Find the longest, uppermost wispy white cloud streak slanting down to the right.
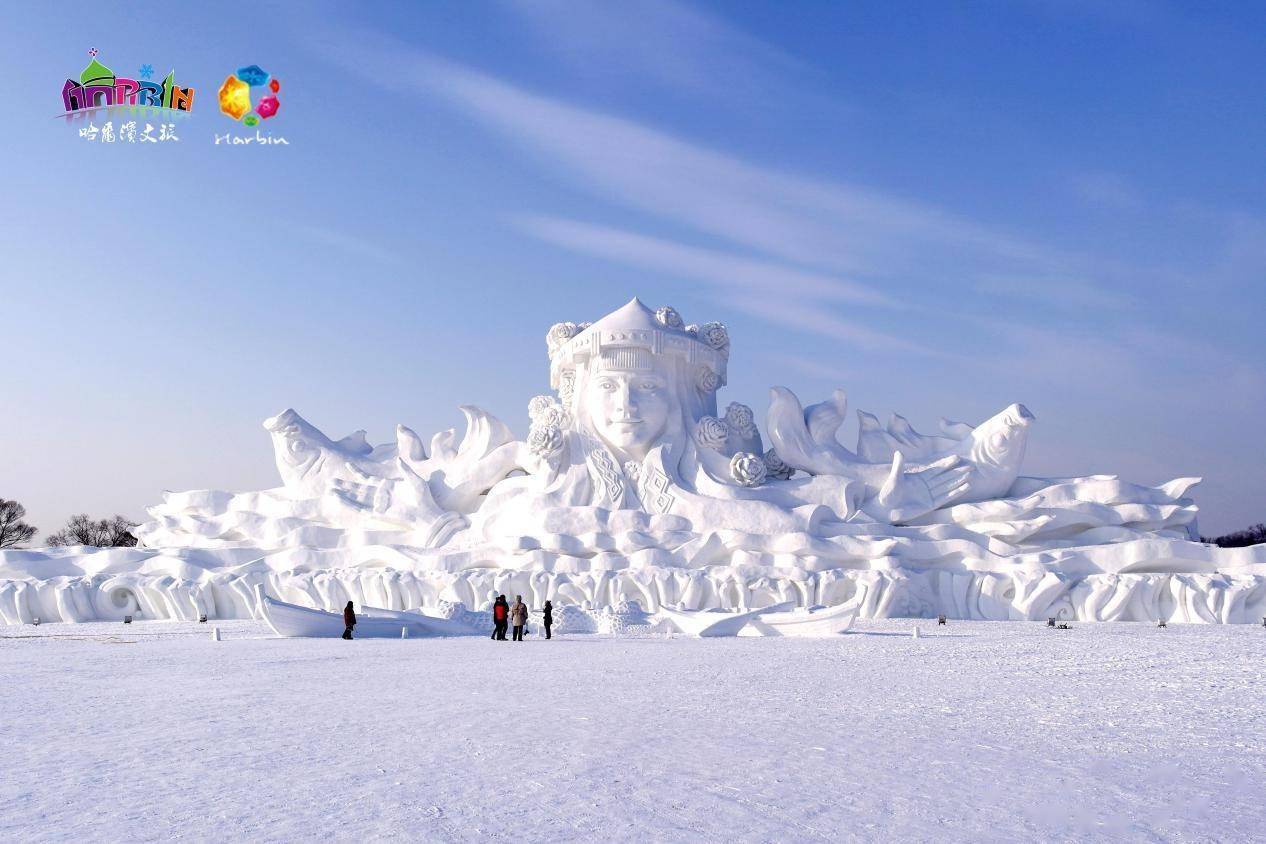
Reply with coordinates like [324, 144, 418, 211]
[313, 33, 1067, 286]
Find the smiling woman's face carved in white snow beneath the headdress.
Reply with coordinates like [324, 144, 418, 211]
[582, 364, 672, 461]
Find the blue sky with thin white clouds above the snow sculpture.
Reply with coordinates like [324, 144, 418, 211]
[0, 0, 1266, 533]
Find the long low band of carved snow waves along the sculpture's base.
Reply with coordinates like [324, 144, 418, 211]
[0, 548, 1266, 624]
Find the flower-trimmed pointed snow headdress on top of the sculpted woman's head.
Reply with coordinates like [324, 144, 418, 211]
[546, 297, 729, 392]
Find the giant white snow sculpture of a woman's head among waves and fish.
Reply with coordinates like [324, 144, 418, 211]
[0, 299, 1266, 634]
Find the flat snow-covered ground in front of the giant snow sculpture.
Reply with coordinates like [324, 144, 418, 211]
[0, 620, 1266, 841]
